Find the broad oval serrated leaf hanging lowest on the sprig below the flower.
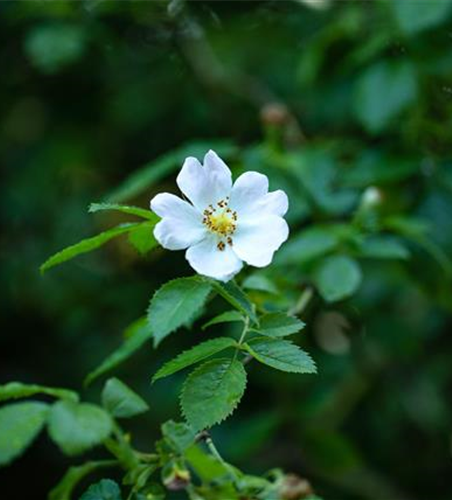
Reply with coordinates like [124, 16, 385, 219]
[181, 358, 246, 431]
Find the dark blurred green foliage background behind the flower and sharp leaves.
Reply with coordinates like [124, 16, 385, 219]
[0, 0, 452, 500]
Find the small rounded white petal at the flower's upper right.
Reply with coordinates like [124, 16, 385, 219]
[229, 172, 268, 215]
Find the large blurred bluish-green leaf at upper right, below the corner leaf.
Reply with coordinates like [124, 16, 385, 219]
[353, 61, 417, 133]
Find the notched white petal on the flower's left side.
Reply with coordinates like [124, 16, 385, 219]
[151, 193, 206, 250]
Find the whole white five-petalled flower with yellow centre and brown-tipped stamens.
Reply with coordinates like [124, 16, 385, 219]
[151, 151, 289, 281]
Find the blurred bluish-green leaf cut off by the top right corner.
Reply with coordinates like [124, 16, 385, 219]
[388, 0, 452, 36]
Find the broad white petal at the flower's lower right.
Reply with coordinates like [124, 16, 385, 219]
[233, 215, 289, 267]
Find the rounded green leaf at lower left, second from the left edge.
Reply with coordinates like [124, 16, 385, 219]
[49, 401, 112, 455]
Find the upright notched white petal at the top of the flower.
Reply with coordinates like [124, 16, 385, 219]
[177, 151, 232, 212]
